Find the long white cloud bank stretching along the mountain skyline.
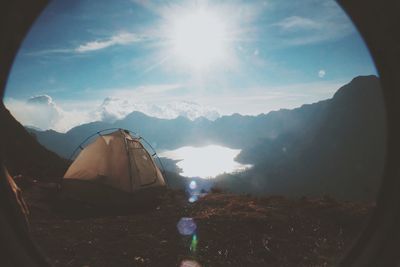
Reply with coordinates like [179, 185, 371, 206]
[5, 81, 345, 132]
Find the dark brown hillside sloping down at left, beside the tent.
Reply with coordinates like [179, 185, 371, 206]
[0, 104, 68, 179]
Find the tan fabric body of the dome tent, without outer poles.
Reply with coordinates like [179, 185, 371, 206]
[64, 130, 165, 193]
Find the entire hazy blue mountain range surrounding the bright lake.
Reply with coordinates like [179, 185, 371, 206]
[27, 76, 386, 199]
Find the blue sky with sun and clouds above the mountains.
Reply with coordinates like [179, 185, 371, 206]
[4, 0, 377, 132]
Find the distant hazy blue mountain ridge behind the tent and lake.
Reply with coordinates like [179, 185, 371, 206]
[28, 101, 326, 158]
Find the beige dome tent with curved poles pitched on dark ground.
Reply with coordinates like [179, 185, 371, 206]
[61, 129, 166, 207]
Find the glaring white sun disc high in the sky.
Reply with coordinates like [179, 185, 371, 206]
[169, 9, 228, 70]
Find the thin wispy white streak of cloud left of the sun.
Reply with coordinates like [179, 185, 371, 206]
[75, 33, 143, 53]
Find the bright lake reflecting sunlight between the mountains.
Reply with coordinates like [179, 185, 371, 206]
[159, 145, 251, 178]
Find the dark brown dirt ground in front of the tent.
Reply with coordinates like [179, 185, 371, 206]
[24, 186, 373, 267]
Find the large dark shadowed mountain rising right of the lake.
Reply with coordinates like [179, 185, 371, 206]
[218, 76, 386, 199]
